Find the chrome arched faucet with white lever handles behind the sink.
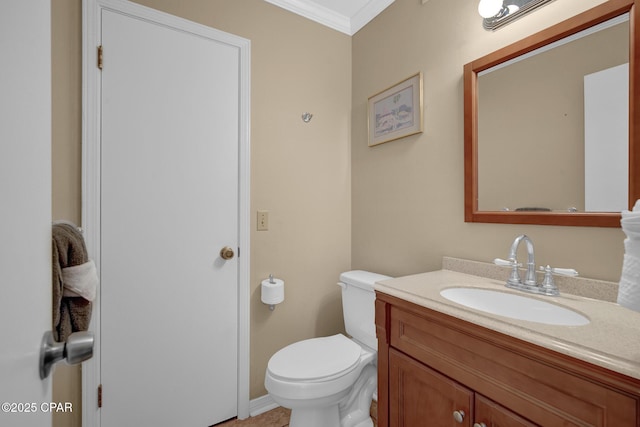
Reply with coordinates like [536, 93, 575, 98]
[493, 234, 578, 295]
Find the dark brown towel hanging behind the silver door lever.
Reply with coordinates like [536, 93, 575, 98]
[51, 222, 91, 342]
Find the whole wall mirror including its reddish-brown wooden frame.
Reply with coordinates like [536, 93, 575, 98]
[464, 0, 640, 227]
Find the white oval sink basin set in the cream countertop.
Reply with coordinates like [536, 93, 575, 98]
[440, 287, 589, 326]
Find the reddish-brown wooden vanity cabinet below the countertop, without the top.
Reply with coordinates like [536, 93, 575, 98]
[376, 293, 640, 427]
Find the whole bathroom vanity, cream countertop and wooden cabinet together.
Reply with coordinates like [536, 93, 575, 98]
[376, 270, 640, 427]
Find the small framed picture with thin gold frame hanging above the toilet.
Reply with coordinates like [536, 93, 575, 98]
[367, 73, 422, 147]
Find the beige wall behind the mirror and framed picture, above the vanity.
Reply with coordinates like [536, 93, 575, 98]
[351, 0, 624, 281]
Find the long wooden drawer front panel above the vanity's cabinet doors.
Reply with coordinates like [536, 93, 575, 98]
[389, 306, 639, 427]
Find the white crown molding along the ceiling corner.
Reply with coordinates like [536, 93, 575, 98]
[265, 0, 395, 36]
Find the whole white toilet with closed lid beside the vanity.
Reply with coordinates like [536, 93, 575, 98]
[264, 270, 390, 427]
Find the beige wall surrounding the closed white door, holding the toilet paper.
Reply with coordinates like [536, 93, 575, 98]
[52, 0, 351, 410]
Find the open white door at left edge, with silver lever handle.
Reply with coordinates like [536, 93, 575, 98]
[0, 0, 52, 427]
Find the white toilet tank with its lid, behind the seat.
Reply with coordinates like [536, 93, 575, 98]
[338, 270, 391, 351]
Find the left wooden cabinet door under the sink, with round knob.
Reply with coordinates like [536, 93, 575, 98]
[389, 349, 473, 427]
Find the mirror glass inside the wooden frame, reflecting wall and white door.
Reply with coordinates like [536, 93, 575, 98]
[477, 14, 629, 212]
